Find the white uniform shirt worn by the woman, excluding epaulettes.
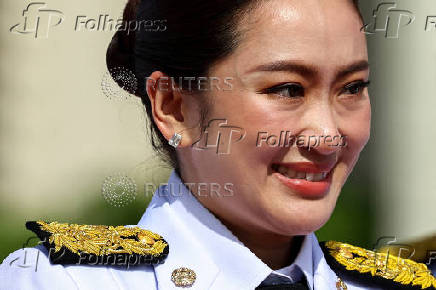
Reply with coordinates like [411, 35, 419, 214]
[0, 172, 376, 290]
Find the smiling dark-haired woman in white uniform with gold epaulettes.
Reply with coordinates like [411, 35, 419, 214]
[1, 0, 436, 290]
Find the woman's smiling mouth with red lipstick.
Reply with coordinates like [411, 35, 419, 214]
[272, 162, 334, 198]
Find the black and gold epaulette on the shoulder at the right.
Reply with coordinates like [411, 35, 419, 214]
[321, 241, 436, 289]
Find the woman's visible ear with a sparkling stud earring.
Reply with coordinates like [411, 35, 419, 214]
[146, 71, 198, 147]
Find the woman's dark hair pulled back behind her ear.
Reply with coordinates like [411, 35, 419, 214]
[106, 0, 362, 169]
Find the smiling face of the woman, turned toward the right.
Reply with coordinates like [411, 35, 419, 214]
[179, 0, 371, 236]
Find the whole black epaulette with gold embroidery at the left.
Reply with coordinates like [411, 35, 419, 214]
[26, 221, 169, 267]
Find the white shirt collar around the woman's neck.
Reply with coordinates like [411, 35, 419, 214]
[138, 171, 322, 289]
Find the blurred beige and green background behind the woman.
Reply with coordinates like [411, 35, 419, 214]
[0, 0, 436, 260]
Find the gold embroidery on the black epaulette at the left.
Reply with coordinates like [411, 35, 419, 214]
[37, 221, 167, 256]
